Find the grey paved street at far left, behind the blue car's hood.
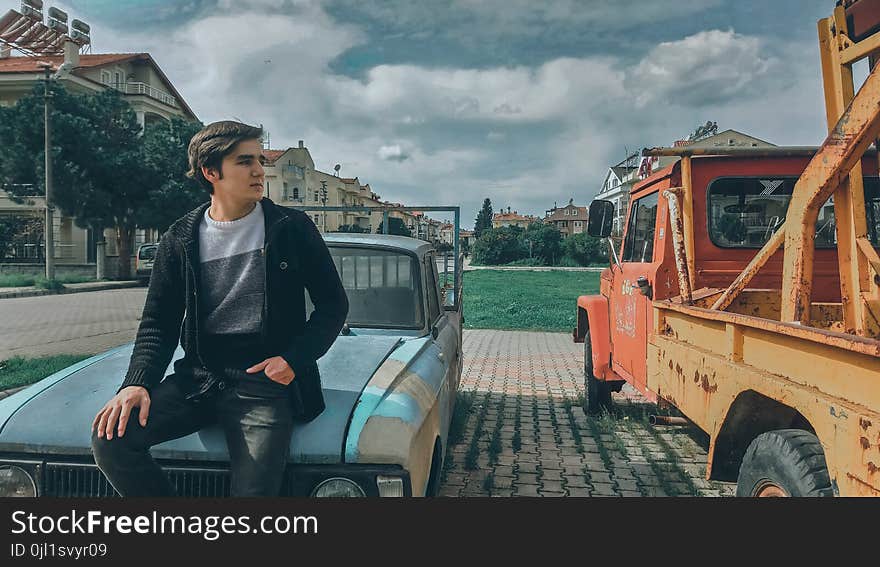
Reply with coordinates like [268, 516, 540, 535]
[0, 287, 147, 360]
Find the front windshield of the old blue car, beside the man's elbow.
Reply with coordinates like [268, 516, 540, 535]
[306, 246, 424, 329]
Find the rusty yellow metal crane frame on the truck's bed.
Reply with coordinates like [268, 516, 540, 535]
[712, 6, 880, 336]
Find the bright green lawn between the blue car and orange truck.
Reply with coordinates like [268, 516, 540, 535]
[464, 270, 599, 332]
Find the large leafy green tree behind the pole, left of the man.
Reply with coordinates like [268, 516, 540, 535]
[0, 83, 208, 278]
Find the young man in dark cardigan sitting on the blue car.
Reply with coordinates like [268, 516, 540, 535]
[92, 121, 348, 496]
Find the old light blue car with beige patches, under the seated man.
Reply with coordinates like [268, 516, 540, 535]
[0, 234, 462, 497]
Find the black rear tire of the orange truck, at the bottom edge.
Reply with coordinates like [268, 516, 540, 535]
[736, 429, 834, 497]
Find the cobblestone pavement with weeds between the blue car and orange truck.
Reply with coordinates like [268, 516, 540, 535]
[440, 330, 735, 496]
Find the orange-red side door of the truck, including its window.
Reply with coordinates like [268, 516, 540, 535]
[610, 193, 658, 390]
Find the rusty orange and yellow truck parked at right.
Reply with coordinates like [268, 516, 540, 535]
[574, 0, 880, 496]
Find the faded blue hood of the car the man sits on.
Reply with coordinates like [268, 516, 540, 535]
[0, 335, 401, 464]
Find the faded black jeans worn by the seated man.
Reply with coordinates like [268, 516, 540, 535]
[92, 376, 293, 496]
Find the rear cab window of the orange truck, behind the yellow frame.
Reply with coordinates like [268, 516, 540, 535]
[707, 177, 880, 248]
